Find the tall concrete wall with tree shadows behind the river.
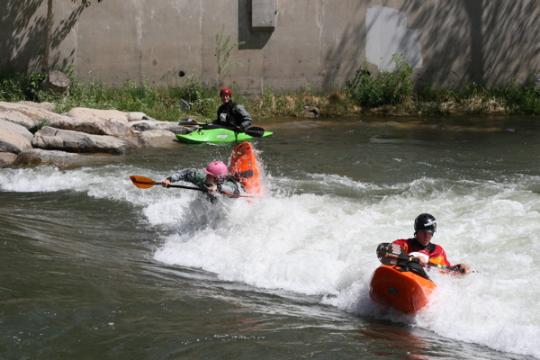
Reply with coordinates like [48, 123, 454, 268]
[0, 0, 540, 92]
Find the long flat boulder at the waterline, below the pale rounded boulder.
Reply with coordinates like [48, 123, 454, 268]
[32, 126, 133, 154]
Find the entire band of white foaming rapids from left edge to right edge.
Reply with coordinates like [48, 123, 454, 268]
[0, 166, 540, 358]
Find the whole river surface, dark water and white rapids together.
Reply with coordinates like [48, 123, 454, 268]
[0, 118, 540, 359]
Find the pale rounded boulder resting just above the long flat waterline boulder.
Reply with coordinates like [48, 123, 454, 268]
[64, 108, 134, 137]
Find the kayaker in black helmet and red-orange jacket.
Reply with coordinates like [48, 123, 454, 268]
[393, 213, 469, 273]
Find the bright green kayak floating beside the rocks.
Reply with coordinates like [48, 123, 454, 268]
[176, 127, 272, 144]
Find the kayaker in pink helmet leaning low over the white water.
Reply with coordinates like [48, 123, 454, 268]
[161, 161, 242, 200]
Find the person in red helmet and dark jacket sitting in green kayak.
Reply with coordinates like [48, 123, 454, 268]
[212, 87, 252, 131]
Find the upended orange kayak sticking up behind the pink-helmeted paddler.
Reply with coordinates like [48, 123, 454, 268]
[229, 141, 262, 195]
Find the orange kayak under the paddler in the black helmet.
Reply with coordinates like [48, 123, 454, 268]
[369, 265, 436, 314]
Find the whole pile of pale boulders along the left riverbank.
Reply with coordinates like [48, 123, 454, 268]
[0, 101, 189, 167]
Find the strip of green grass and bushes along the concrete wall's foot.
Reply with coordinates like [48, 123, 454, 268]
[0, 65, 540, 120]
